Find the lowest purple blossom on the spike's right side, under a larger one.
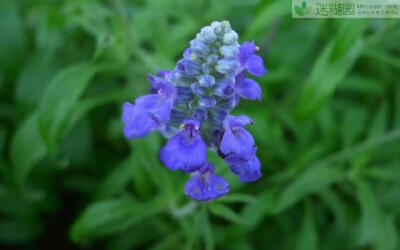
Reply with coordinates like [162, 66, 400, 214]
[225, 147, 262, 182]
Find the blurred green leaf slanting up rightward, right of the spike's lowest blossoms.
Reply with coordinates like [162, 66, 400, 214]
[276, 165, 344, 212]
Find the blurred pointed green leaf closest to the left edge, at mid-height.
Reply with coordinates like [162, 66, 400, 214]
[10, 113, 46, 185]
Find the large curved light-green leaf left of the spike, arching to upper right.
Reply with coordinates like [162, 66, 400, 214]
[39, 63, 98, 153]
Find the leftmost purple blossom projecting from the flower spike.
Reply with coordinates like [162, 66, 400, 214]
[122, 77, 175, 139]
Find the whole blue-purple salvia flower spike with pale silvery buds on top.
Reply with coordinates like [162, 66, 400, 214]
[122, 21, 266, 201]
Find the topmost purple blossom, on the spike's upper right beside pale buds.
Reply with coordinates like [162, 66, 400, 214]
[238, 42, 267, 76]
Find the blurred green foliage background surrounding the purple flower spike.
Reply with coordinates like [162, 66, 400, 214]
[0, 0, 400, 250]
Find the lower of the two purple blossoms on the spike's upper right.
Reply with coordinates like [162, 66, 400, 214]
[235, 71, 261, 100]
